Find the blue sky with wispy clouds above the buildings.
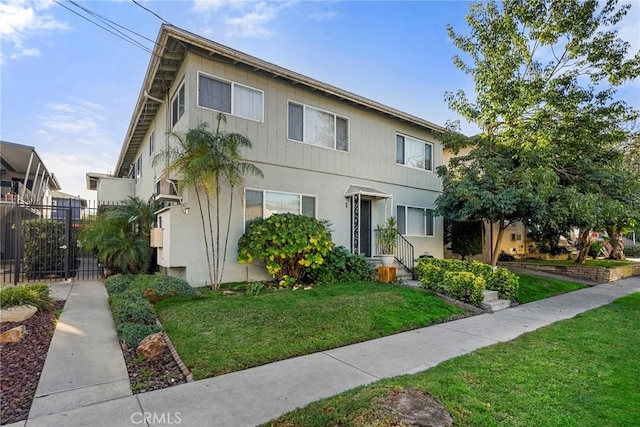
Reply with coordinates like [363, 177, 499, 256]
[0, 0, 640, 199]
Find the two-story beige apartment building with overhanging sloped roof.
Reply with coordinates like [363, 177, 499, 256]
[87, 25, 444, 284]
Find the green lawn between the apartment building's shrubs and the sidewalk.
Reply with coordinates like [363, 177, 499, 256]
[156, 283, 465, 379]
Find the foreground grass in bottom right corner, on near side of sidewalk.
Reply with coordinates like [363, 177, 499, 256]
[269, 294, 640, 427]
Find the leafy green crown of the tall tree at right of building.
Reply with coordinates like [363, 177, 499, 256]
[437, 0, 640, 265]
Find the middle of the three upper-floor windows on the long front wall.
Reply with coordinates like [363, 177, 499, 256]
[287, 102, 349, 151]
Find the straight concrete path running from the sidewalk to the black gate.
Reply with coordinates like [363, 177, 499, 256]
[29, 281, 132, 418]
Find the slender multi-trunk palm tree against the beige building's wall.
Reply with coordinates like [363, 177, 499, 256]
[154, 113, 263, 289]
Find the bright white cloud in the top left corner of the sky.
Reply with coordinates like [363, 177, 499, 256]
[0, 0, 69, 59]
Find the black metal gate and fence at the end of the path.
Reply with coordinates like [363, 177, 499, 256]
[0, 203, 102, 284]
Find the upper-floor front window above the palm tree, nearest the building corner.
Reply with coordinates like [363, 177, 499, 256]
[198, 73, 264, 122]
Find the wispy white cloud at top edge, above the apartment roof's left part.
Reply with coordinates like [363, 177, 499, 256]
[193, 0, 297, 38]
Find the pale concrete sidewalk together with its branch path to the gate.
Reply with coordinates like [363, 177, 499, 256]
[16, 277, 640, 427]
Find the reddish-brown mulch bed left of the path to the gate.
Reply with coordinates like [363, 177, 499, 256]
[0, 301, 64, 424]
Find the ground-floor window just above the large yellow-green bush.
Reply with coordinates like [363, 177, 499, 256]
[244, 190, 316, 228]
